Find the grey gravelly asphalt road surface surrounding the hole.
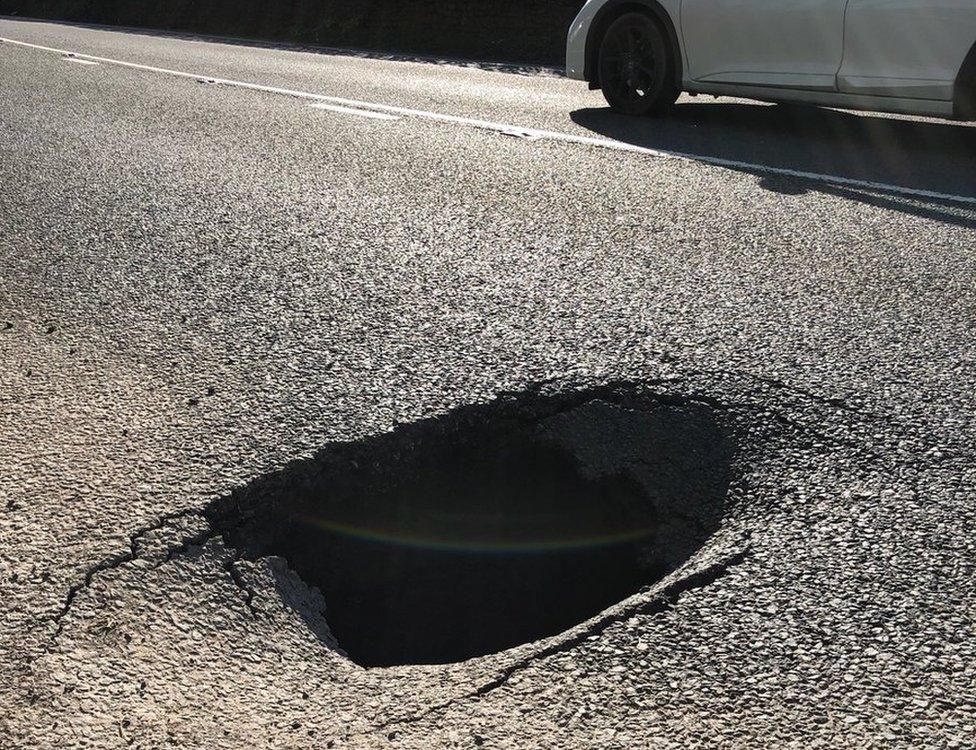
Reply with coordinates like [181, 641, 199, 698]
[0, 20, 976, 750]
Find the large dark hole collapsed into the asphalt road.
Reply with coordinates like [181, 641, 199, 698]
[211, 387, 731, 666]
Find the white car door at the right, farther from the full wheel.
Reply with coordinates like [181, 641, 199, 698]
[837, 0, 976, 100]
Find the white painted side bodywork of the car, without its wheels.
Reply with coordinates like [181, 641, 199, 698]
[566, 0, 976, 117]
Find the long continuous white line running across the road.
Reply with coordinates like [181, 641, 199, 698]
[0, 37, 976, 205]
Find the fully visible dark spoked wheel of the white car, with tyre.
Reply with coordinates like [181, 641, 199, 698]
[599, 13, 678, 115]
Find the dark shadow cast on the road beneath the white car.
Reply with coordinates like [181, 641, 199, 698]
[570, 102, 976, 226]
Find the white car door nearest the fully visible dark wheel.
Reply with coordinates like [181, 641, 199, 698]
[681, 0, 847, 91]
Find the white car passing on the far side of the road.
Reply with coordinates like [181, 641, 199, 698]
[566, 0, 976, 119]
